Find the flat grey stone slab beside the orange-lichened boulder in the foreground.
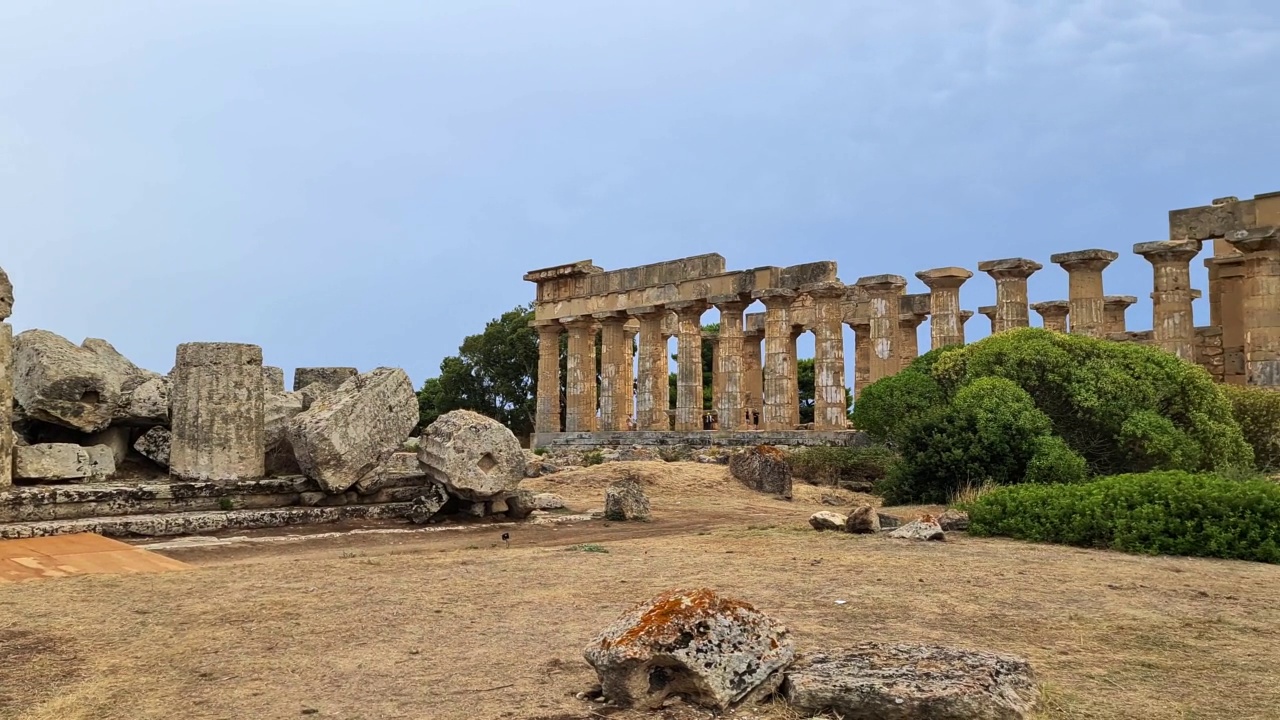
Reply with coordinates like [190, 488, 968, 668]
[783, 642, 1039, 720]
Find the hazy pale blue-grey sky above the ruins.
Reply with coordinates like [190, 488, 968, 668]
[0, 0, 1280, 384]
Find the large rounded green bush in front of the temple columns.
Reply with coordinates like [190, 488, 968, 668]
[852, 328, 1253, 502]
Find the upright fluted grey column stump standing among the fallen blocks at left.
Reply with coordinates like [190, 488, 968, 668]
[169, 342, 266, 482]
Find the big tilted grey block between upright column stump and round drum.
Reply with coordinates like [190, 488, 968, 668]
[288, 368, 417, 492]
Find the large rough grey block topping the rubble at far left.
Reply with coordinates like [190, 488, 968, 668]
[14, 331, 120, 433]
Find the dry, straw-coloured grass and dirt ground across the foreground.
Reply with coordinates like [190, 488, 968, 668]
[0, 462, 1280, 720]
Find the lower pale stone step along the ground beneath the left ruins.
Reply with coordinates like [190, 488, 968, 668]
[0, 502, 412, 539]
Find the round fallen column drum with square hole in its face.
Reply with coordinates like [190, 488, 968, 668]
[415, 406, 525, 502]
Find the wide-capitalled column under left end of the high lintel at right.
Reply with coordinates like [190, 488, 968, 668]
[1133, 240, 1201, 363]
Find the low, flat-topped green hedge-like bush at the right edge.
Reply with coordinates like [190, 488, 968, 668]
[966, 471, 1280, 562]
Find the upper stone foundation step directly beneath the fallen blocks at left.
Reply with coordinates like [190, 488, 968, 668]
[0, 477, 421, 523]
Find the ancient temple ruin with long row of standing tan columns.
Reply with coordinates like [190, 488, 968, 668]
[525, 192, 1280, 446]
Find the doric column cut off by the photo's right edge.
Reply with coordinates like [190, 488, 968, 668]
[1226, 225, 1280, 387]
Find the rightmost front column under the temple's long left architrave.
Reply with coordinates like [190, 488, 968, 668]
[796, 282, 849, 430]
